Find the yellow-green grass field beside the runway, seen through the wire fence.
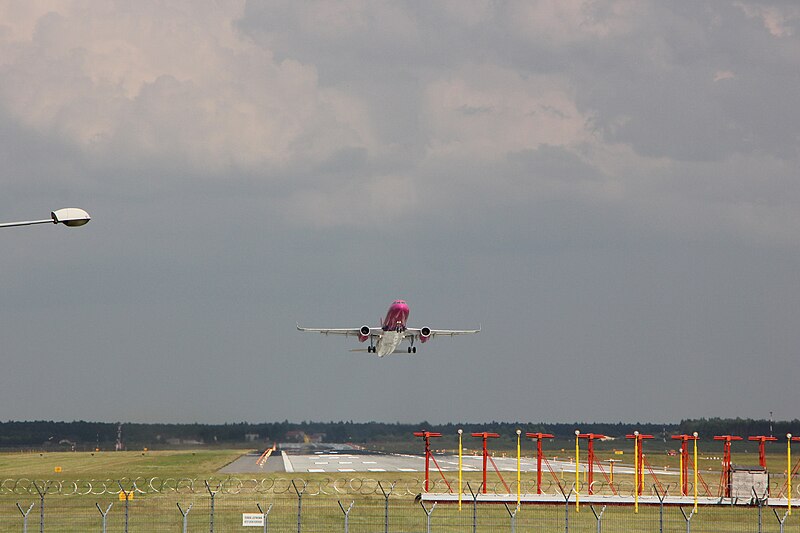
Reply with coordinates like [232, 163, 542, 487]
[0, 450, 800, 533]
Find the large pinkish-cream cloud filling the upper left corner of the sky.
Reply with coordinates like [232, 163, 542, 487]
[0, 1, 373, 173]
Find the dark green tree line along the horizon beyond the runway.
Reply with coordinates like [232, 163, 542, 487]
[0, 418, 800, 450]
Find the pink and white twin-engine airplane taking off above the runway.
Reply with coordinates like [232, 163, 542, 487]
[297, 300, 481, 357]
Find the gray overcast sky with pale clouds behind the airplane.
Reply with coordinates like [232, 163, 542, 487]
[0, 0, 800, 423]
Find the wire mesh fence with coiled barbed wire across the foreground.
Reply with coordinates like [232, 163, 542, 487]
[0, 478, 800, 533]
